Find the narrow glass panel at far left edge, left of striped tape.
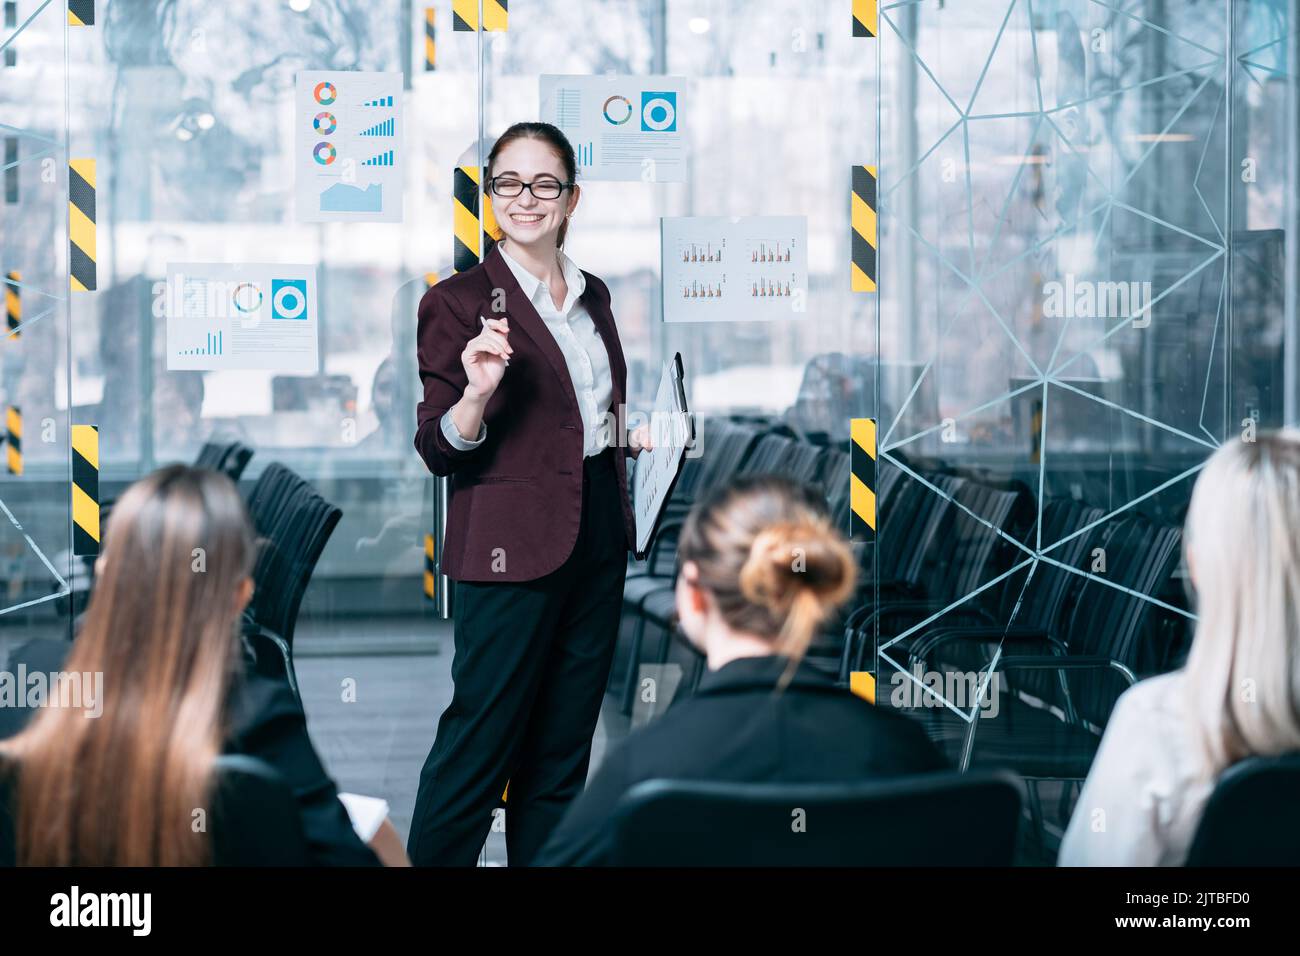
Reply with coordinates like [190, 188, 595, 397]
[0, 4, 74, 658]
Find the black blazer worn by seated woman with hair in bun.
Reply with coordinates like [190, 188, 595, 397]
[537, 656, 949, 866]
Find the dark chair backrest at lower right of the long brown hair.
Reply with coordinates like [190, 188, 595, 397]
[209, 754, 311, 866]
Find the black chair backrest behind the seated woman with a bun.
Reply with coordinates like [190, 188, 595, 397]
[614, 771, 1021, 866]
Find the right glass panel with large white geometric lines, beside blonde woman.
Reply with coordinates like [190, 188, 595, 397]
[868, 0, 1296, 858]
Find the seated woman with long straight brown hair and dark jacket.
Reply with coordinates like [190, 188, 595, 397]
[0, 466, 402, 866]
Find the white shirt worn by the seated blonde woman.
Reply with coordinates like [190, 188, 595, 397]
[1057, 671, 1214, 866]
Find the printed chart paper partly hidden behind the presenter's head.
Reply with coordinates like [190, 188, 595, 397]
[538, 74, 686, 182]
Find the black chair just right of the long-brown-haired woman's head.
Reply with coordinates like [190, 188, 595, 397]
[243, 462, 343, 696]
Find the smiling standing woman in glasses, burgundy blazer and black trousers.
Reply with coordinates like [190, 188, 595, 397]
[408, 122, 649, 866]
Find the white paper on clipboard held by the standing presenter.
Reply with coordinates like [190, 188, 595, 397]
[632, 352, 692, 558]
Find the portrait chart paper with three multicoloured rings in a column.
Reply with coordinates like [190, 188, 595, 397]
[294, 70, 406, 222]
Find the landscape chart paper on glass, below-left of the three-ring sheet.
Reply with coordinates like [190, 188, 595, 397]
[165, 263, 317, 372]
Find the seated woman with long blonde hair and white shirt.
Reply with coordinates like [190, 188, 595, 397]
[1058, 429, 1300, 866]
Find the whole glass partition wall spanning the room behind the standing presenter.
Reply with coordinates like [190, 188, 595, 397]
[0, 0, 1300, 852]
